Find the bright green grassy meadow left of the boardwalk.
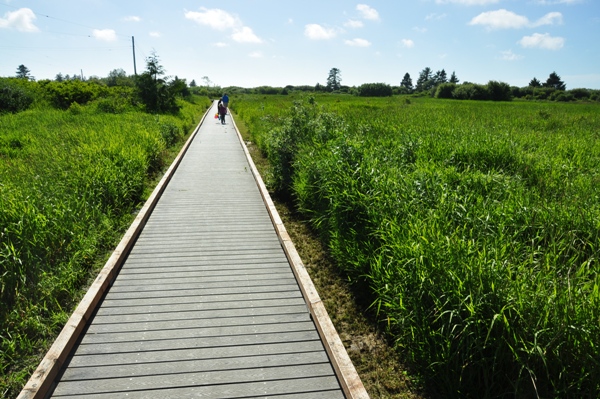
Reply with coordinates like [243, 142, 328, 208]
[0, 94, 210, 397]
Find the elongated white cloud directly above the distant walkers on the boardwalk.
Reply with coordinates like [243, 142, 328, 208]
[185, 7, 263, 43]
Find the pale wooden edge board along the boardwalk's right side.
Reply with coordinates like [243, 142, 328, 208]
[231, 117, 369, 399]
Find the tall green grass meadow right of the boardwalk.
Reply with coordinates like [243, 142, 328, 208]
[231, 95, 600, 398]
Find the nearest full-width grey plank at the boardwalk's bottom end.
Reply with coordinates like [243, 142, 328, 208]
[53, 363, 335, 397]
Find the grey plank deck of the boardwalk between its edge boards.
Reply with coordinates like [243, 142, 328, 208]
[24, 104, 367, 399]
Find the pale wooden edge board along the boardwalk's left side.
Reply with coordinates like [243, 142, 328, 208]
[17, 107, 212, 399]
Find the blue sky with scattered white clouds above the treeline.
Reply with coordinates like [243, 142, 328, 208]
[0, 0, 600, 89]
